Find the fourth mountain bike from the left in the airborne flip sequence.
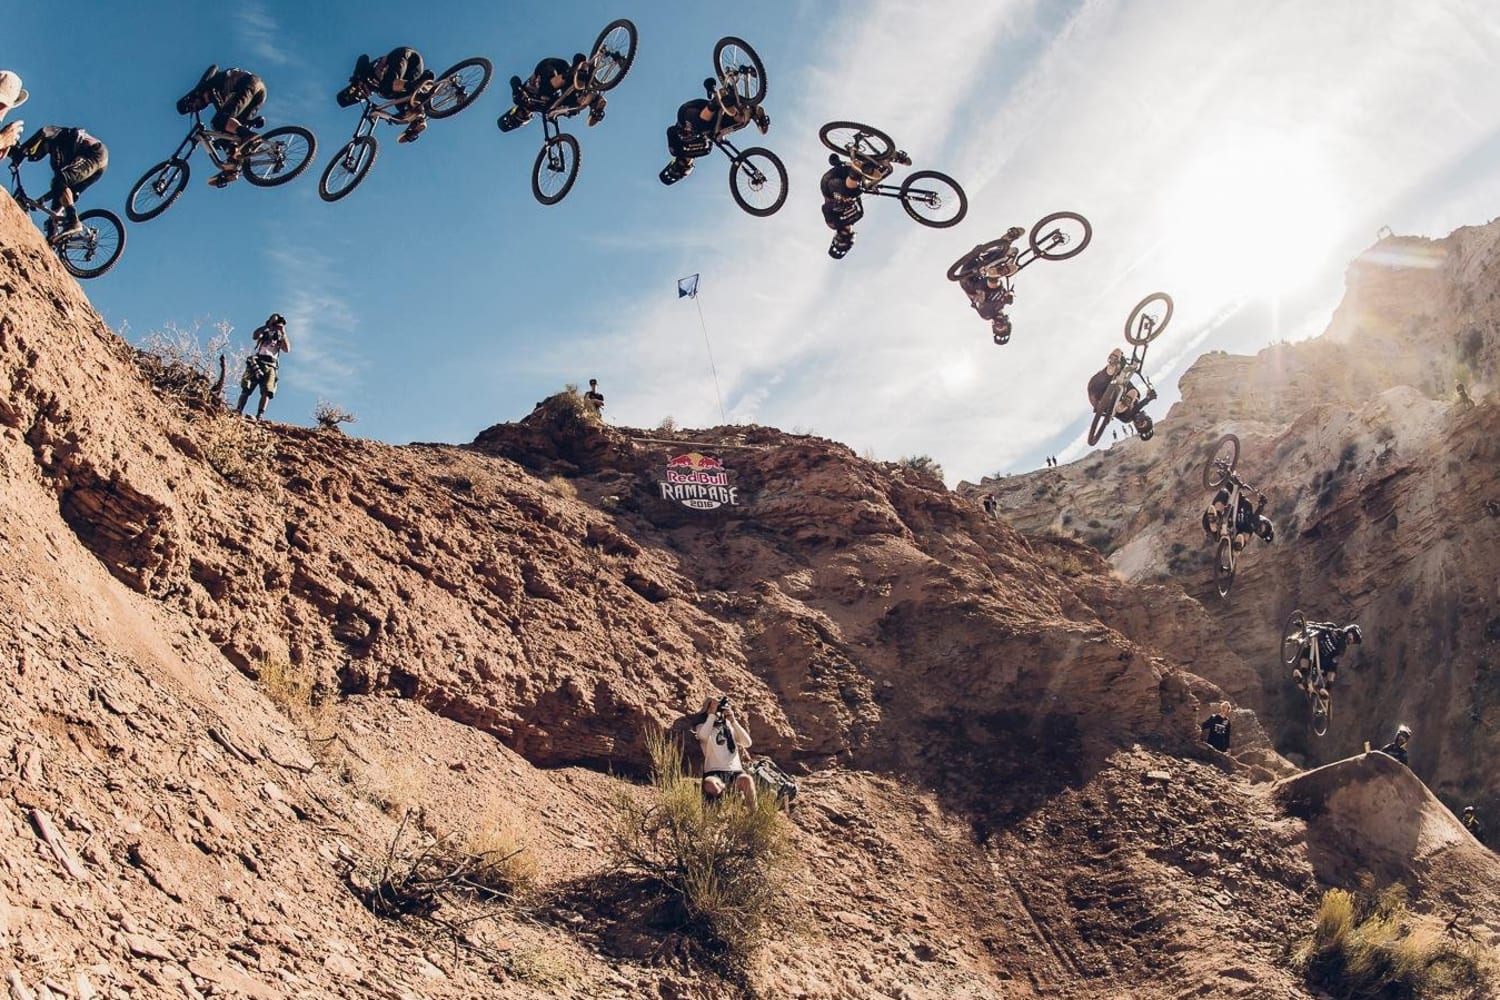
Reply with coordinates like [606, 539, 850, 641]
[500, 18, 636, 205]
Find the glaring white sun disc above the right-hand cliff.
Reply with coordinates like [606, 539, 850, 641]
[1161, 135, 1344, 300]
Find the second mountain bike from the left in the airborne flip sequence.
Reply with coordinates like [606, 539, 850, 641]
[125, 111, 318, 222]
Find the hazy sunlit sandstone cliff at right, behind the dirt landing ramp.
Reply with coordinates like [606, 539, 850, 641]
[984, 223, 1500, 813]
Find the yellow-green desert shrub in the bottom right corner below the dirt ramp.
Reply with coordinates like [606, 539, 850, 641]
[1295, 880, 1493, 1000]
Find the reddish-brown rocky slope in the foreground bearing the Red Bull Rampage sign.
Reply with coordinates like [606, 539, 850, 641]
[0, 204, 1500, 1000]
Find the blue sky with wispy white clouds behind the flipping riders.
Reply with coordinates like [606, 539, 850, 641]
[0, 0, 1500, 483]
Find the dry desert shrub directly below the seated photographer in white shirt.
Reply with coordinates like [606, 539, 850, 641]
[609, 730, 795, 969]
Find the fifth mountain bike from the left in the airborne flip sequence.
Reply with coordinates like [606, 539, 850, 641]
[660, 36, 786, 219]
